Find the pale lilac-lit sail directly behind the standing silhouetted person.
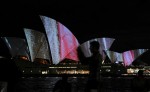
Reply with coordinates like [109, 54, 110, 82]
[80, 38, 115, 59]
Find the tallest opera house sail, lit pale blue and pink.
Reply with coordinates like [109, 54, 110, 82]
[40, 16, 79, 64]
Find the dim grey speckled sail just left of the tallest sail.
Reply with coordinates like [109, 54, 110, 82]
[24, 28, 50, 62]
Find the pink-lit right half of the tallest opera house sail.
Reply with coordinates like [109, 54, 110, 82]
[57, 22, 79, 61]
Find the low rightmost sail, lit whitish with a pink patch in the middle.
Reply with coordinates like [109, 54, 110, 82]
[105, 49, 148, 66]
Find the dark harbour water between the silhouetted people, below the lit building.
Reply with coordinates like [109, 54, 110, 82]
[12, 77, 150, 92]
